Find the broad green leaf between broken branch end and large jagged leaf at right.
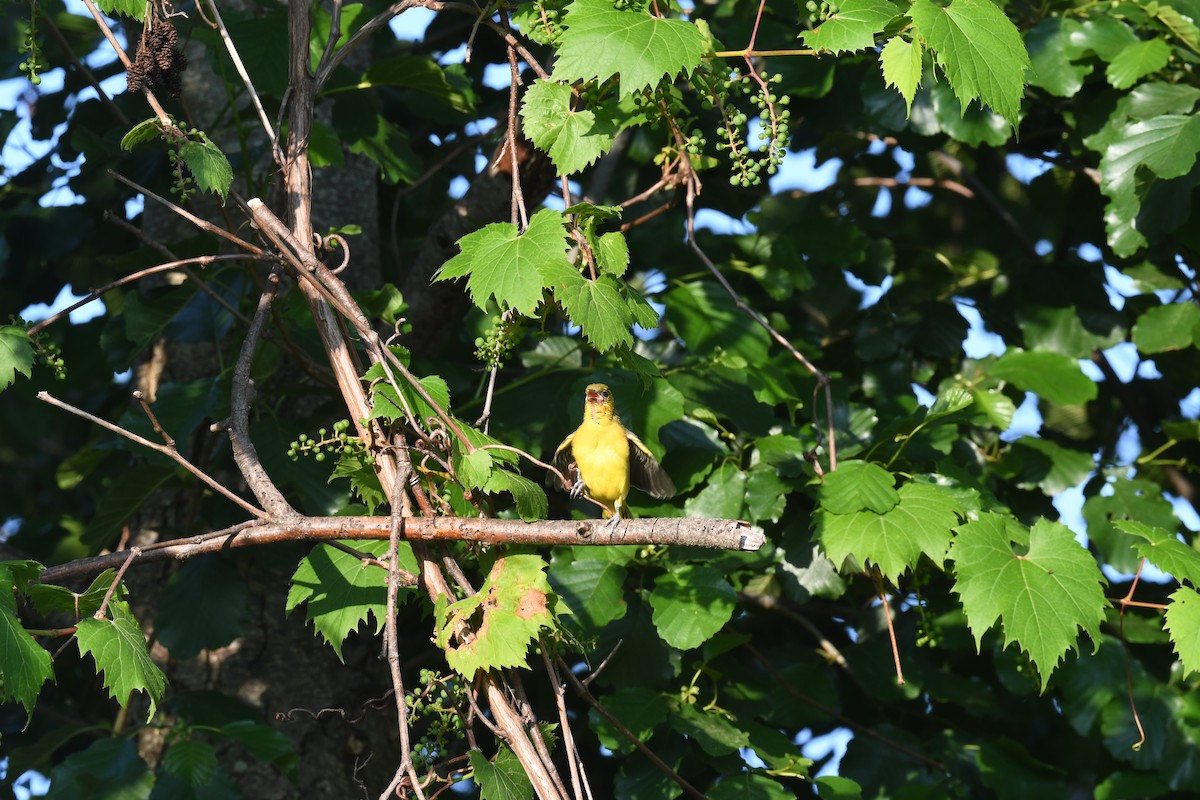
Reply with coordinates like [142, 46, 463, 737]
[816, 479, 959, 581]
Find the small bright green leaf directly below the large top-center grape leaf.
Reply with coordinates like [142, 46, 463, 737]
[521, 79, 617, 175]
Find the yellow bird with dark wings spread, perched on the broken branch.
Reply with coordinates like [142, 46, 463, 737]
[554, 384, 674, 527]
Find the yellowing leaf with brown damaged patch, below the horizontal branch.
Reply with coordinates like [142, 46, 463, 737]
[436, 555, 553, 679]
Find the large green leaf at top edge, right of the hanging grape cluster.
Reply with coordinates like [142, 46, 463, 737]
[908, 0, 1030, 127]
